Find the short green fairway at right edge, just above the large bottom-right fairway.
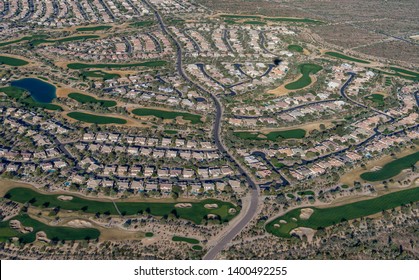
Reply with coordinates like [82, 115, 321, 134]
[361, 152, 419, 182]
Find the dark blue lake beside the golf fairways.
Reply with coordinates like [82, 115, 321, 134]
[11, 78, 57, 103]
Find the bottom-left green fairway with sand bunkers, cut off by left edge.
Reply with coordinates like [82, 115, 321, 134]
[0, 214, 100, 243]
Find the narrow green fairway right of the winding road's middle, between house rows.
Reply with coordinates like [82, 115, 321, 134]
[233, 129, 306, 141]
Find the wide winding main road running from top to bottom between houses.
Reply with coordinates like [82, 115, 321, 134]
[143, 0, 259, 260]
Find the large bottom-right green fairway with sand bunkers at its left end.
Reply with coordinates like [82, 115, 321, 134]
[266, 187, 419, 238]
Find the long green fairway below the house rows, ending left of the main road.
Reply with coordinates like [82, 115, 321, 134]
[5, 188, 239, 224]
